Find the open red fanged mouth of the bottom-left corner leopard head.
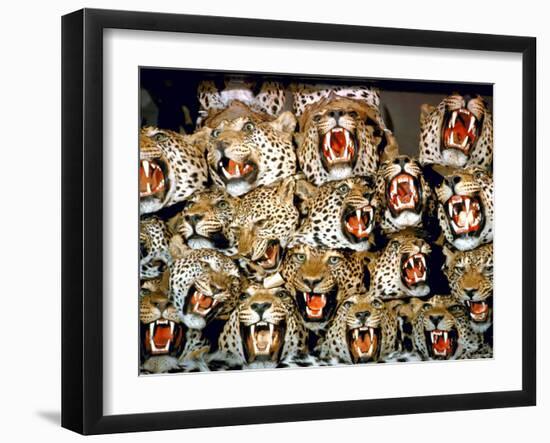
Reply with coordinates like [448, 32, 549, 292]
[141, 319, 184, 356]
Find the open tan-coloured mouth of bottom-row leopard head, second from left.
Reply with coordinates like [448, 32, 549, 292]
[241, 321, 286, 363]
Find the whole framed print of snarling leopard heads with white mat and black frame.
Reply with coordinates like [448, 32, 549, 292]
[62, 9, 536, 434]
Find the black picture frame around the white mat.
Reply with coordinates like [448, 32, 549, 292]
[62, 9, 536, 434]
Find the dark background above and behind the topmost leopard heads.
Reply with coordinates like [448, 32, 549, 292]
[140, 67, 493, 155]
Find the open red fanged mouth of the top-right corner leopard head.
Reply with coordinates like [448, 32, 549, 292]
[443, 109, 479, 155]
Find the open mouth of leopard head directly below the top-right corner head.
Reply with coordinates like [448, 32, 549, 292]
[446, 195, 484, 235]
